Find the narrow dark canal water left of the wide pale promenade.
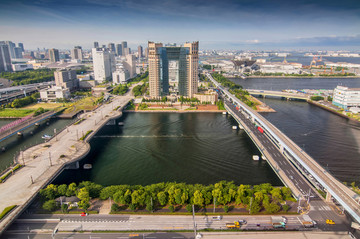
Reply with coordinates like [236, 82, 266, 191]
[0, 119, 72, 172]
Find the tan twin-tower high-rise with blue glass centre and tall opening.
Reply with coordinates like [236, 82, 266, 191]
[148, 42, 199, 98]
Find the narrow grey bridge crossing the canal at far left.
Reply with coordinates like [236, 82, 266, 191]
[0, 111, 57, 142]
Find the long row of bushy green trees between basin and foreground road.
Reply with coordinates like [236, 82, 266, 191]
[40, 181, 294, 213]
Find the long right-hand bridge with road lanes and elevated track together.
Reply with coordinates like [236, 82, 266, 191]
[206, 74, 360, 222]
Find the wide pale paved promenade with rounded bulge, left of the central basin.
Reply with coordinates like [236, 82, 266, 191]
[0, 92, 133, 233]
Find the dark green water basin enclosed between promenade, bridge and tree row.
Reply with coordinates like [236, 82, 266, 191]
[54, 113, 281, 185]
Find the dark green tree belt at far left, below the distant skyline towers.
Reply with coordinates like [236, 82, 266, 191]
[0, 69, 54, 85]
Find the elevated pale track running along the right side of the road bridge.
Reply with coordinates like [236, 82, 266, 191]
[206, 73, 360, 223]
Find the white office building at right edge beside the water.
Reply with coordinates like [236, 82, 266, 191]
[332, 85, 360, 110]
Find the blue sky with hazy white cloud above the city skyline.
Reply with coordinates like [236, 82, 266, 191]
[0, 0, 360, 51]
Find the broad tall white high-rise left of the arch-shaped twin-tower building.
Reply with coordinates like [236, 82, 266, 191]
[92, 48, 116, 83]
